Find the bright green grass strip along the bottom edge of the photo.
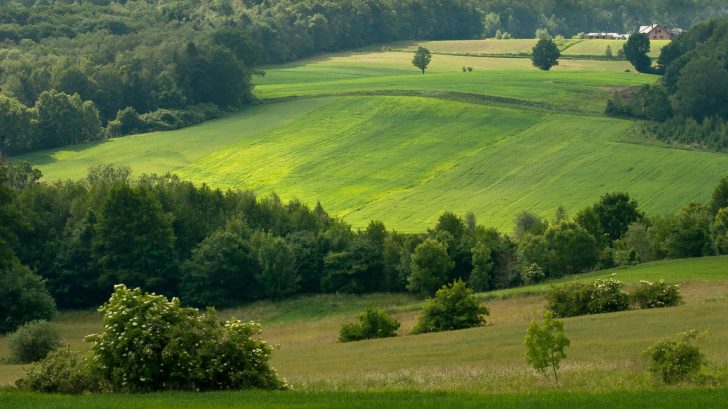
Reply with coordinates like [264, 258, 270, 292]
[0, 389, 728, 409]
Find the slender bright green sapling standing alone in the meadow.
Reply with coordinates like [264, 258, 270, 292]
[524, 311, 571, 382]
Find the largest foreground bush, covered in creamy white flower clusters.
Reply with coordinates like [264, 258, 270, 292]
[86, 285, 286, 391]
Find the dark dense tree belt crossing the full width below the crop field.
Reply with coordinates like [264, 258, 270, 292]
[0, 164, 728, 327]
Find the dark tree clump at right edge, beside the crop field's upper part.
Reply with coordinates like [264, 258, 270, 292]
[607, 18, 728, 151]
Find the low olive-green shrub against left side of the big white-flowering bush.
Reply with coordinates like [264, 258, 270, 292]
[15, 346, 101, 393]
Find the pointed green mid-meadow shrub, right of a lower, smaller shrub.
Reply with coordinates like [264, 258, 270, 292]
[412, 280, 489, 334]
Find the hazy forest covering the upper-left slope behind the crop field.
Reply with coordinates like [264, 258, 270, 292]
[0, 0, 482, 155]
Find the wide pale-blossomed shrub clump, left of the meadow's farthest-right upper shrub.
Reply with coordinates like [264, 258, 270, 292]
[546, 278, 629, 318]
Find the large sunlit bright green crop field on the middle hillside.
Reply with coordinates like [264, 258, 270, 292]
[14, 45, 728, 231]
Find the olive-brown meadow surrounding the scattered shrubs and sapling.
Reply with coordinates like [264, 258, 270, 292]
[0, 257, 728, 393]
